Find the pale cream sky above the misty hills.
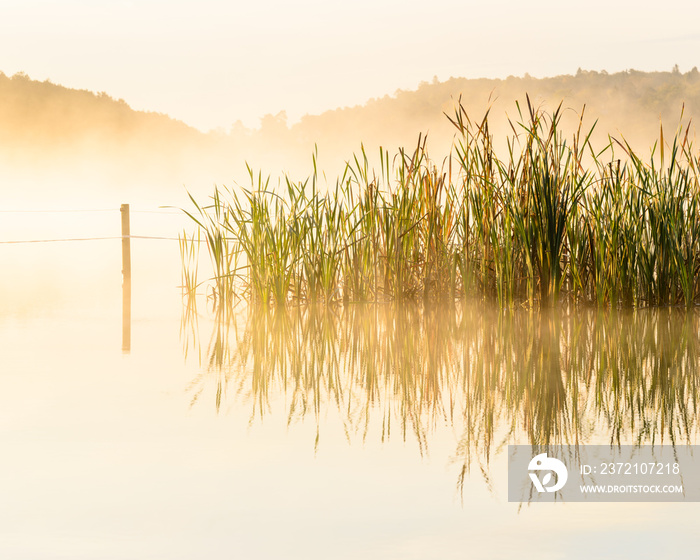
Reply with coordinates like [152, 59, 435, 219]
[0, 0, 700, 131]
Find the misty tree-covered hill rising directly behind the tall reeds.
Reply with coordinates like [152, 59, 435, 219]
[229, 68, 700, 174]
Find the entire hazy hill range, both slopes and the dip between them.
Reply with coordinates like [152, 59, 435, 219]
[0, 68, 700, 197]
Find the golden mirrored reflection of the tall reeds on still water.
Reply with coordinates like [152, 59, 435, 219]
[182, 305, 700, 471]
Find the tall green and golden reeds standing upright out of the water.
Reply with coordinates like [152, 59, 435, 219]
[181, 97, 700, 309]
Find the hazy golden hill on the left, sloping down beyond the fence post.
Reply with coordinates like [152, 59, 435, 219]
[0, 73, 232, 202]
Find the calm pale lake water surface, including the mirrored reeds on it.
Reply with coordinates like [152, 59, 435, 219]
[0, 217, 700, 559]
